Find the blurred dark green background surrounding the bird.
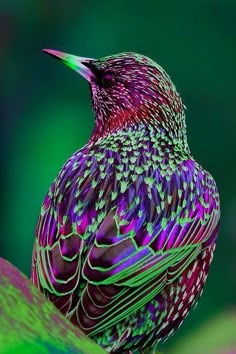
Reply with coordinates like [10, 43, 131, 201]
[0, 0, 236, 354]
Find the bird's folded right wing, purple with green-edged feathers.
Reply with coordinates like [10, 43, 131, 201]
[77, 161, 219, 334]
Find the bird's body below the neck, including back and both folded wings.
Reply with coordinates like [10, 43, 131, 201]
[32, 126, 219, 353]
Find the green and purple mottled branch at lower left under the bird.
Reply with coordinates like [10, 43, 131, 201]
[0, 258, 105, 354]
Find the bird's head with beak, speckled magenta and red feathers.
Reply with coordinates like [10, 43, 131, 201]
[44, 49, 185, 140]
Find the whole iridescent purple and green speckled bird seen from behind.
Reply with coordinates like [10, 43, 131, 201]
[31, 49, 220, 354]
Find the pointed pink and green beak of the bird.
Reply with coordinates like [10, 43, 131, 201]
[43, 49, 95, 82]
